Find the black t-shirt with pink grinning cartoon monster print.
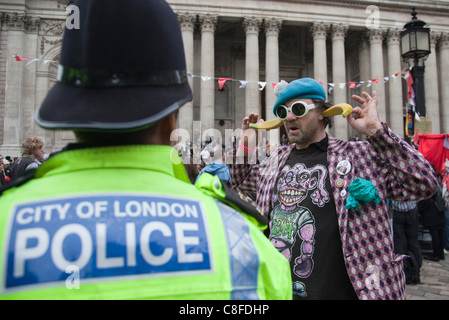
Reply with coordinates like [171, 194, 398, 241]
[270, 137, 357, 300]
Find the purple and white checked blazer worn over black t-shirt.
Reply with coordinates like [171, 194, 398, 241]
[229, 124, 437, 300]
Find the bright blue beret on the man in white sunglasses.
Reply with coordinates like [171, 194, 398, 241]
[273, 78, 326, 115]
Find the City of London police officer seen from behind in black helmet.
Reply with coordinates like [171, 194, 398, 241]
[0, 0, 292, 299]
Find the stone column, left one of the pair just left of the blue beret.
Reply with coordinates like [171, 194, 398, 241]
[243, 17, 262, 115]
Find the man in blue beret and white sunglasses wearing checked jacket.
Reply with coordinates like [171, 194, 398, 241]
[229, 78, 437, 300]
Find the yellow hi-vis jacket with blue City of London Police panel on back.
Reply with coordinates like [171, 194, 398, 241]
[0, 146, 292, 300]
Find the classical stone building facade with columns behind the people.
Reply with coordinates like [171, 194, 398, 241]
[0, 0, 449, 156]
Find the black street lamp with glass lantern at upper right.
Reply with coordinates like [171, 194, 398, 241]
[401, 8, 430, 117]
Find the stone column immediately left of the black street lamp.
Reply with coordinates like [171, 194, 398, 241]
[387, 28, 404, 137]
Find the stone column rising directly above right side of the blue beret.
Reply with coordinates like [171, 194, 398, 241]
[311, 22, 329, 99]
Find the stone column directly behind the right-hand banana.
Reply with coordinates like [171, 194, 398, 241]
[331, 24, 349, 140]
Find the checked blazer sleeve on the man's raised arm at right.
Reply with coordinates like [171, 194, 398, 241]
[366, 123, 438, 201]
